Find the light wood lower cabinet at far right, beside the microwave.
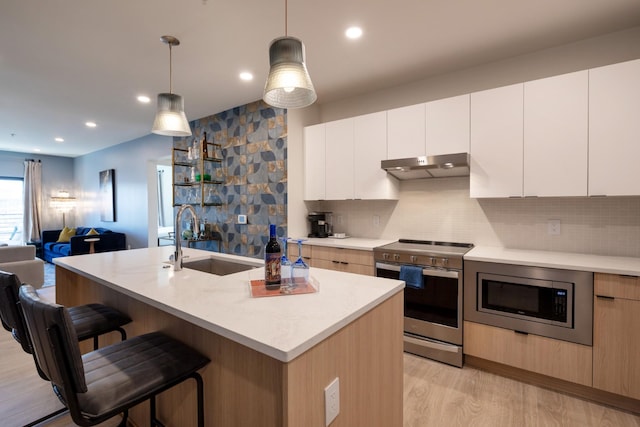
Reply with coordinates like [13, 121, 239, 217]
[593, 274, 640, 399]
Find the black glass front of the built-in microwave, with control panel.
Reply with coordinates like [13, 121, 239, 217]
[482, 279, 568, 323]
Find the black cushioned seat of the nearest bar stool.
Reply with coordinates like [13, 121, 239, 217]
[78, 332, 209, 418]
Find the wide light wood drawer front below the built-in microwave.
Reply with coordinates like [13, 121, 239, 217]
[464, 321, 593, 387]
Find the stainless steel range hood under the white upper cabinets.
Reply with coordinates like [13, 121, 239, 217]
[381, 153, 469, 180]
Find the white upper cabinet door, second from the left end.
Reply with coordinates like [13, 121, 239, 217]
[325, 118, 354, 200]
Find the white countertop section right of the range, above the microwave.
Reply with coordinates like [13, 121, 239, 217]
[464, 246, 640, 276]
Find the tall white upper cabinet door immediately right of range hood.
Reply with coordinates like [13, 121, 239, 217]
[469, 84, 523, 198]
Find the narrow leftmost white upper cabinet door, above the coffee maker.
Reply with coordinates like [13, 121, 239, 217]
[304, 124, 325, 200]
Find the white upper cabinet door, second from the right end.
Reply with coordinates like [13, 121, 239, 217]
[524, 71, 589, 197]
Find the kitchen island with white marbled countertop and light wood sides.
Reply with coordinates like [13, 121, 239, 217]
[55, 247, 404, 427]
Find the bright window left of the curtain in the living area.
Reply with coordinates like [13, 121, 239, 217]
[0, 177, 23, 245]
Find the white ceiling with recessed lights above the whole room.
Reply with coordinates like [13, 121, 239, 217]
[0, 0, 640, 157]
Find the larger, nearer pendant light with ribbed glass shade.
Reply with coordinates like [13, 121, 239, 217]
[262, 0, 318, 108]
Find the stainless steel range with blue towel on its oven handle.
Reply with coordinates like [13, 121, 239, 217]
[373, 239, 473, 367]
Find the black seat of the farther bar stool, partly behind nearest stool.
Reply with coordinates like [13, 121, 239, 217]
[68, 304, 131, 341]
